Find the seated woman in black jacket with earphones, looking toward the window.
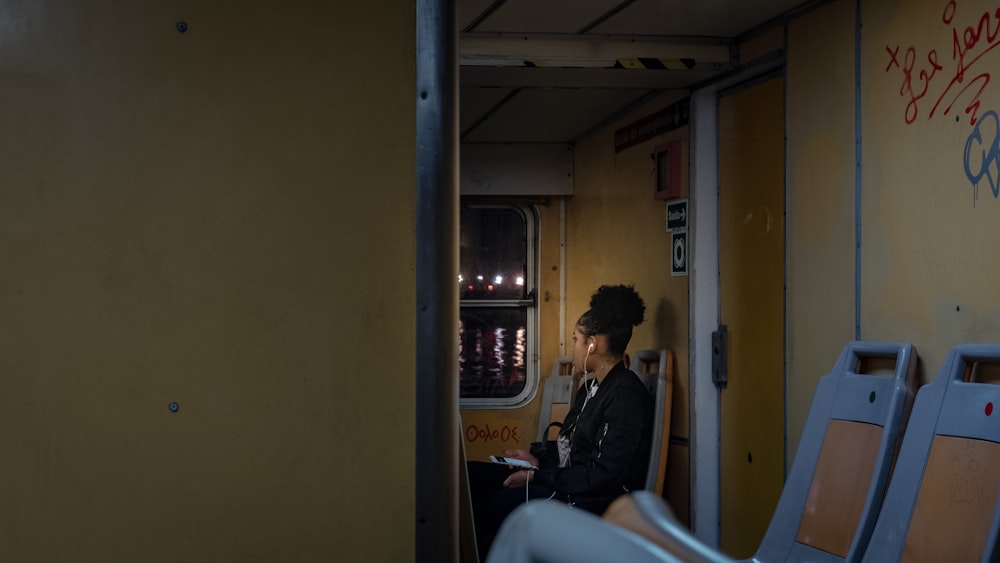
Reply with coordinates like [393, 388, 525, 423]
[469, 285, 653, 552]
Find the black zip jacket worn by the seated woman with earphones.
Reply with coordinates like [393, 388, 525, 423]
[532, 363, 653, 514]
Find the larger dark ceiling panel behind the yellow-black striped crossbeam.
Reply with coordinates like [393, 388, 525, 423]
[462, 88, 648, 143]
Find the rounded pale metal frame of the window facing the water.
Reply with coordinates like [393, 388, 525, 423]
[456, 203, 541, 409]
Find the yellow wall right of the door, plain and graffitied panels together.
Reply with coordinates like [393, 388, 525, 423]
[788, 0, 1000, 462]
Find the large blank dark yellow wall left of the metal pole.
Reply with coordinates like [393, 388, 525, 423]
[0, 0, 415, 562]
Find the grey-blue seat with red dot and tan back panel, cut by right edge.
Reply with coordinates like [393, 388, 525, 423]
[864, 344, 1000, 562]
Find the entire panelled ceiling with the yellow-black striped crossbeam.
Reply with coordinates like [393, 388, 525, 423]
[458, 0, 830, 143]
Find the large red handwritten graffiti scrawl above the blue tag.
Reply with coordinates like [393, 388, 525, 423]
[885, 0, 1000, 125]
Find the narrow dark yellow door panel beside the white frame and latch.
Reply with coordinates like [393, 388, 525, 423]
[719, 78, 785, 558]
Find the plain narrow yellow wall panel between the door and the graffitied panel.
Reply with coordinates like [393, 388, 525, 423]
[785, 0, 855, 464]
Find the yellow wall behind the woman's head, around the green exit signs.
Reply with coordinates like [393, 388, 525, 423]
[566, 96, 690, 521]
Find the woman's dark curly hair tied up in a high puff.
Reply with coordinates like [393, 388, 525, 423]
[577, 285, 646, 355]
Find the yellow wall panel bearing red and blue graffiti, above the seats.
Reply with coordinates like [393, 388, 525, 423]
[861, 0, 1000, 377]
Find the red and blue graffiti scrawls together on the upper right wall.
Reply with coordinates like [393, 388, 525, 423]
[885, 0, 1000, 206]
